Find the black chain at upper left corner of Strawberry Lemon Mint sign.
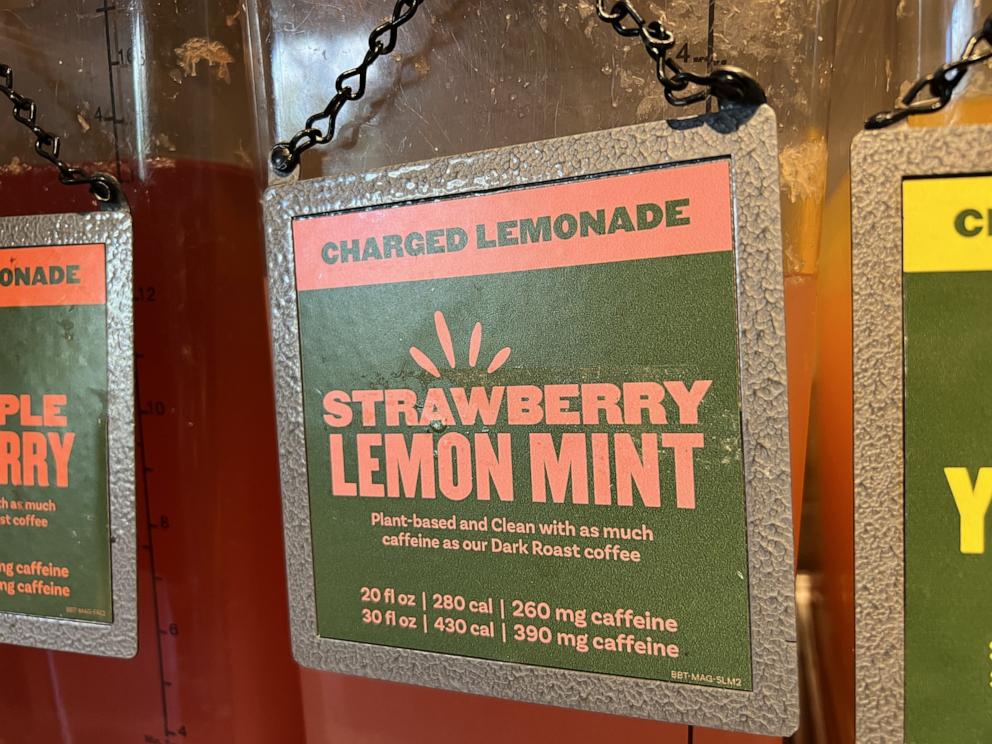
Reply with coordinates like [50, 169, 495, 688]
[270, 0, 424, 175]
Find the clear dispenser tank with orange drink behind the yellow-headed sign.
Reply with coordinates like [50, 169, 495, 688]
[803, 0, 992, 742]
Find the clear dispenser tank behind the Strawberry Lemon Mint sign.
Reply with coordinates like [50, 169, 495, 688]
[249, 0, 836, 744]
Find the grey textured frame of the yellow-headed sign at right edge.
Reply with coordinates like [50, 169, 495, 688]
[851, 126, 992, 743]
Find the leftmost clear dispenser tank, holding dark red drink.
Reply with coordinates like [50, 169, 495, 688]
[0, 5, 303, 744]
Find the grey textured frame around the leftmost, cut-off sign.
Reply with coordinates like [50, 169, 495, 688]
[0, 207, 138, 658]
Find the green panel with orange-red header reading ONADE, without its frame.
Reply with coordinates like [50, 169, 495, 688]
[0, 245, 113, 623]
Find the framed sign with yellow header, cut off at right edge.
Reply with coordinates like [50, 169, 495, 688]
[852, 126, 992, 742]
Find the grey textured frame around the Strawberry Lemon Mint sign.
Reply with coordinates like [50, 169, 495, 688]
[264, 106, 799, 735]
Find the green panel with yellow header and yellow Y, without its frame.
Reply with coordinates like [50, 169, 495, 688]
[903, 176, 992, 744]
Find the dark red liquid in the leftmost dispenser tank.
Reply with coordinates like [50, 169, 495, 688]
[0, 162, 304, 744]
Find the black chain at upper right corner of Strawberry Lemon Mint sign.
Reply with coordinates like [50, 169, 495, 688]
[596, 0, 767, 106]
